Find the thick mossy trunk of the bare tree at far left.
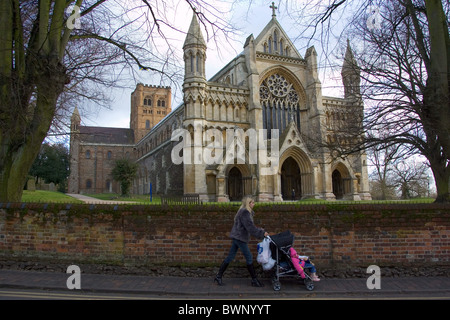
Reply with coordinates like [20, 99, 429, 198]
[0, 0, 70, 202]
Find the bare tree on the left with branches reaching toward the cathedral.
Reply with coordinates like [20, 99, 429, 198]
[0, 0, 232, 202]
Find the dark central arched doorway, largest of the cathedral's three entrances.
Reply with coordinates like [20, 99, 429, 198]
[281, 157, 302, 200]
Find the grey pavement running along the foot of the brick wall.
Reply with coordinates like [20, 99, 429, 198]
[0, 270, 450, 299]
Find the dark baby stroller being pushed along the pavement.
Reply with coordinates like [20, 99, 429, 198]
[268, 230, 314, 291]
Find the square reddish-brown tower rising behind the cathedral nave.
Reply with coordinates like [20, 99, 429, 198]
[130, 83, 172, 142]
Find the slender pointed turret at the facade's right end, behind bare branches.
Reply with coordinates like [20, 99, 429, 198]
[341, 39, 361, 99]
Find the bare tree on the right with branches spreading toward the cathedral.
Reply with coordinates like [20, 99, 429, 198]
[286, 0, 450, 202]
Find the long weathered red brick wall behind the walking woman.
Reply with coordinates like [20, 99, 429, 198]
[0, 204, 450, 268]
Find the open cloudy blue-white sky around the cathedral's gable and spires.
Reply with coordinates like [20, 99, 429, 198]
[76, 0, 342, 128]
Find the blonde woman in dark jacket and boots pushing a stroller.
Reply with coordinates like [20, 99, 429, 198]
[214, 196, 269, 287]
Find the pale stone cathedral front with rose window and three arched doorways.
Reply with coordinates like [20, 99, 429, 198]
[70, 13, 371, 201]
